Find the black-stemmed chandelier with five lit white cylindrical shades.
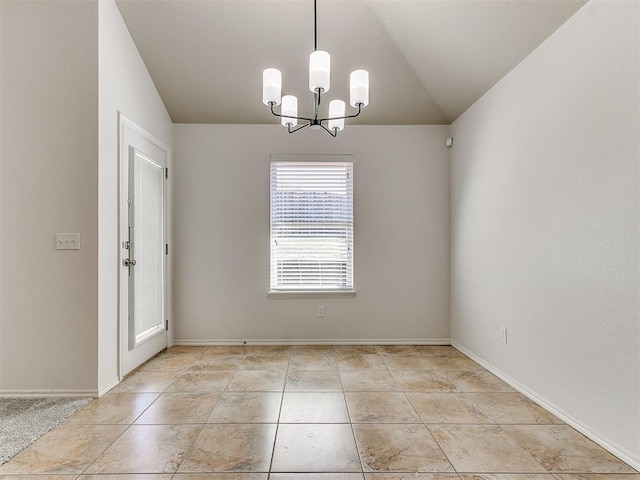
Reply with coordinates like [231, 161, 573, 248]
[262, 0, 369, 137]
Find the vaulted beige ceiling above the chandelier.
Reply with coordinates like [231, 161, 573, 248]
[116, 0, 587, 125]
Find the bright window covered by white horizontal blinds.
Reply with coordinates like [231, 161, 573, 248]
[271, 155, 353, 293]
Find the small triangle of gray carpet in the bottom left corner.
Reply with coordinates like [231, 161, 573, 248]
[0, 397, 91, 465]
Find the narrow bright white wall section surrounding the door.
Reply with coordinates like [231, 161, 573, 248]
[98, 0, 172, 392]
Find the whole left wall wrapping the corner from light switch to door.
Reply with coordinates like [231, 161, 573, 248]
[0, 0, 172, 394]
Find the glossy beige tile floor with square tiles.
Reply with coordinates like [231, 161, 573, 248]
[0, 346, 640, 480]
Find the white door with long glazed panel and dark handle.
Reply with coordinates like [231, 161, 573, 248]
[120, 115, 169, 377]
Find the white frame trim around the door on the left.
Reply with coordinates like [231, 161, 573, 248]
[117, 112, 172, 380]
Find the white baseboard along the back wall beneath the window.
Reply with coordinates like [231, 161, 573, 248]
[173, 338, 451, 346]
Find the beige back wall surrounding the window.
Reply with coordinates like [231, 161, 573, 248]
[174, 125, 449, 343]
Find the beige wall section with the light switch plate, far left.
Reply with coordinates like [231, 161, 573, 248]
[0, 0, 98, 393]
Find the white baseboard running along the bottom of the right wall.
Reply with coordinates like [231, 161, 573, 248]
[451, 340, 640, 470]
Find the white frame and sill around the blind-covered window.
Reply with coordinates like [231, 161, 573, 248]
[268, 154, 356, 298]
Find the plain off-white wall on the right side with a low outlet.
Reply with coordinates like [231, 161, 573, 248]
[452, 0, 640, 467]
